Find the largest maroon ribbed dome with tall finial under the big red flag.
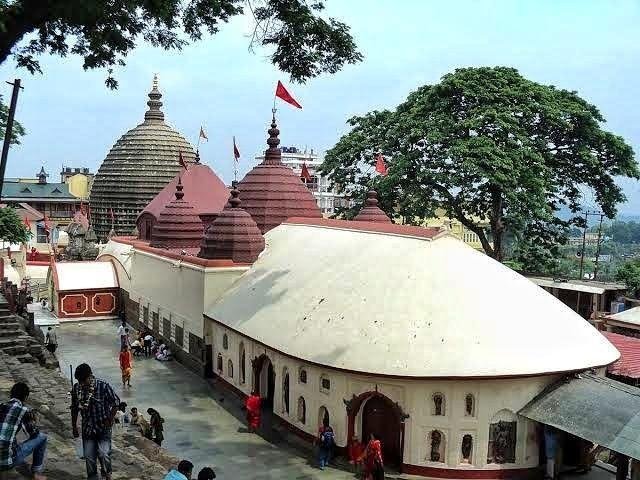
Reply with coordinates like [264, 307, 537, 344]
[238, 116, 322, 234]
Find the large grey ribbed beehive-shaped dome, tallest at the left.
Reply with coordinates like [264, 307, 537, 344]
[90, 77, 195, 240]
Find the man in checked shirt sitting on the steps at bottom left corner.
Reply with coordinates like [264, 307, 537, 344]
[0, 382, 47, 480]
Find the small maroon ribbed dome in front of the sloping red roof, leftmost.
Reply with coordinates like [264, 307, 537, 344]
[150, 178, 203, 248]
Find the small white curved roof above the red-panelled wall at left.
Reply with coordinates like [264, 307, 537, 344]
[53, 261, 118, 292]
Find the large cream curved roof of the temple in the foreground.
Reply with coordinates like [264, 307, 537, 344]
[206, 220, 619, 377]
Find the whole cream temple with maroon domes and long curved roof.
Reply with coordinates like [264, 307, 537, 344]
[56, 113, 619, 479]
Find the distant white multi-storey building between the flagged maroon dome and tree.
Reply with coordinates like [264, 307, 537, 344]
[256, 147, 349, 217]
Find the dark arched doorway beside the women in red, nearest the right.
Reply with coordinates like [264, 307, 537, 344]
[362, 396, 402, 466]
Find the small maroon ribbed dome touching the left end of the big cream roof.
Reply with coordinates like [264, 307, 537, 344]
[198, 188, 264, 263]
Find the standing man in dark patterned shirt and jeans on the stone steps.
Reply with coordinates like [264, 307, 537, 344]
[71, 363, 120, 480]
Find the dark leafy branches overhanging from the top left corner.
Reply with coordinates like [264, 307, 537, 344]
[0, 0, 362, 88]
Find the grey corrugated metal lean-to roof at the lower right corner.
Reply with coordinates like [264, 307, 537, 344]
[518, 373, 640, 459]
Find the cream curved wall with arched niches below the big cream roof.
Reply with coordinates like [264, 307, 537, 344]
[205, 319, 558, 478]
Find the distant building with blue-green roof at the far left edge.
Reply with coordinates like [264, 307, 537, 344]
[2, 167, 81, 229]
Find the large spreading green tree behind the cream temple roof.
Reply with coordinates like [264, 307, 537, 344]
[322, 67, 639, 260]
